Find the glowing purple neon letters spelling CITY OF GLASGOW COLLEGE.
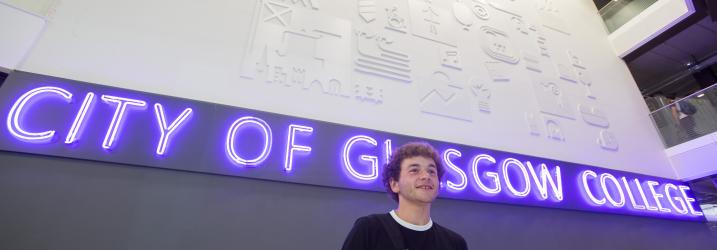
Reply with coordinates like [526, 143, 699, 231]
[0, 76, 703, 220]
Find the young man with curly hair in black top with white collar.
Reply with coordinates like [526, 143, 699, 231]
[342, 142, 468, 250]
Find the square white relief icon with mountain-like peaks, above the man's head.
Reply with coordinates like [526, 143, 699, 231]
[420, 71, 472, 121]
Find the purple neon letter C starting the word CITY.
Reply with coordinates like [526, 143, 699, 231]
[6, 86, 72, 143]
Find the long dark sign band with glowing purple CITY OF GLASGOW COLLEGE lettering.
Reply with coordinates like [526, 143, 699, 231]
[0, 72, 704, 221]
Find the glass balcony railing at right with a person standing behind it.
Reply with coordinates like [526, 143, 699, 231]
[650, 84, 717, 148]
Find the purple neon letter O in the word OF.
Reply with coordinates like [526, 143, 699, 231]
[225, 116, 273, 167]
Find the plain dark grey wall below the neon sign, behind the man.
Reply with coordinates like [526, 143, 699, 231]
[0, 152, 717, 250]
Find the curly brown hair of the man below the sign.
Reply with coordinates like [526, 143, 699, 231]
[382, 142, 445, 202]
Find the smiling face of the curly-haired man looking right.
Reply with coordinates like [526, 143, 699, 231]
[391, 156, 439, 205]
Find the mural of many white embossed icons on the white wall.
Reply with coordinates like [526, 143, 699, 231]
[241, 0, 620, 152]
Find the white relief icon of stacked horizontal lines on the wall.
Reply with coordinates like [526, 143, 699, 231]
[354, 31, 411, 82]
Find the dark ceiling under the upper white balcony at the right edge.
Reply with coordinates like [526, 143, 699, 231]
[593, 0, 717, 96]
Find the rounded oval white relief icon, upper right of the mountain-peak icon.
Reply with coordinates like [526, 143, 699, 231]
[481, 26, 520, 64]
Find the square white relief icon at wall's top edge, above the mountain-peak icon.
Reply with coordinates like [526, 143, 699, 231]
[408, 0, 456, 47]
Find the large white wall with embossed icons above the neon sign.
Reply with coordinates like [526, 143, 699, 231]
[14, 0, 675, 178]
